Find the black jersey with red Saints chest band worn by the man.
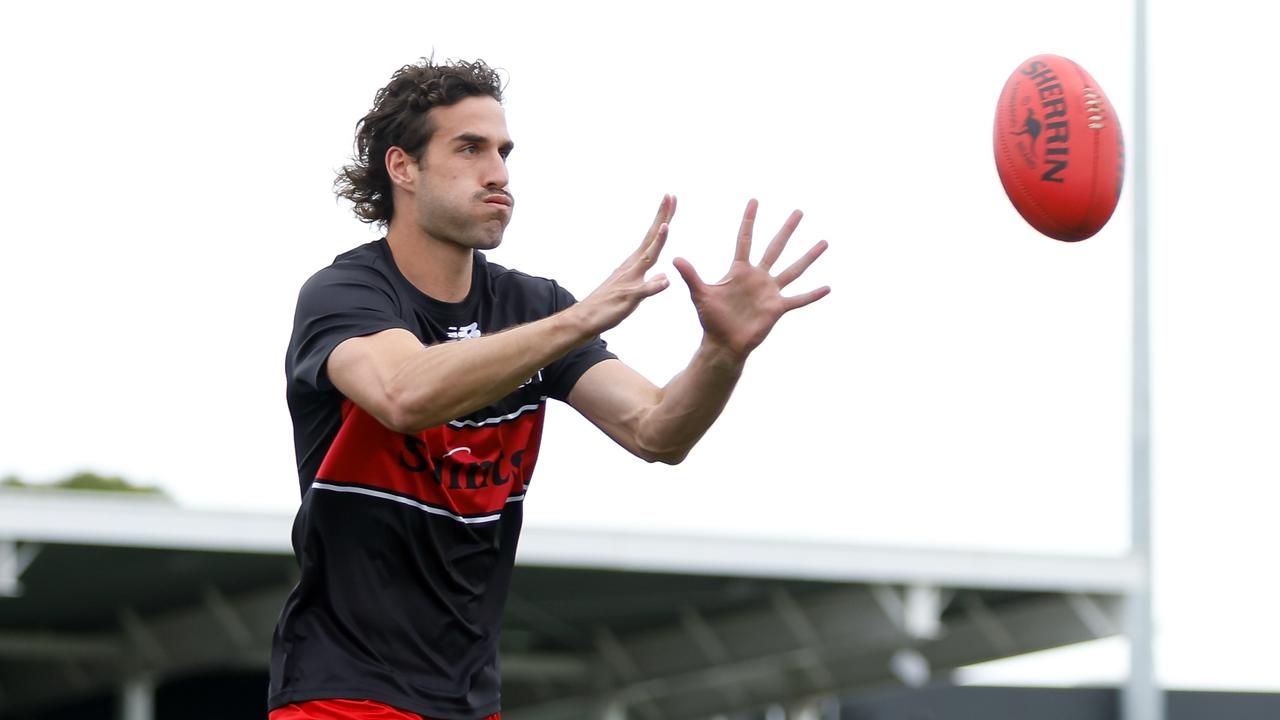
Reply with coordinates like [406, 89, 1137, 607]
[269, 240, 613, 719]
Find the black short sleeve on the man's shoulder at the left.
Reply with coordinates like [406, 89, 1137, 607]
[285, 263, 408, 392]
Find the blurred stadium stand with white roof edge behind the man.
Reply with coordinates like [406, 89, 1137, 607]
[0, 489, 1143, 720]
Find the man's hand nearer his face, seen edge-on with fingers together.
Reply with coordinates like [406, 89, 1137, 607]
[572, 195, 676, 334]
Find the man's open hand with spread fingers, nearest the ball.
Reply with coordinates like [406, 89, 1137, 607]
[675, 200, 831, 360]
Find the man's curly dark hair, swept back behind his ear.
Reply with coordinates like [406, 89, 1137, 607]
[333, 58, 502, 227]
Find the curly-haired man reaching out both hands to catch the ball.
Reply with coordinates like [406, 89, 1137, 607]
[269, 60, 828, 720]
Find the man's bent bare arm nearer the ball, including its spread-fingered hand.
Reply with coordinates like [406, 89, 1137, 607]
[568, 200, 831, 464]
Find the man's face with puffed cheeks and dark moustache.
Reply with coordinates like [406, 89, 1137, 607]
[415, 96, 516, 250]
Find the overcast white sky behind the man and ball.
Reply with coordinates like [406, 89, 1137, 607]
[0, 0, 1280, 689]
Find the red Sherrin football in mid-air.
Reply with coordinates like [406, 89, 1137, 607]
[995, 55, 1124, 242]
